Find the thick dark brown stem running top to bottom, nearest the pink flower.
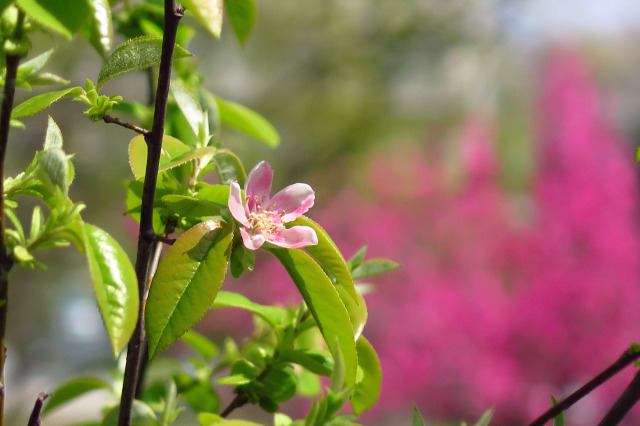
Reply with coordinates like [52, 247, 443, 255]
[118, 0, 184, 426]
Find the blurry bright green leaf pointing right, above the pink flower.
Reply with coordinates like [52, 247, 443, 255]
[215, 96, 280, 147]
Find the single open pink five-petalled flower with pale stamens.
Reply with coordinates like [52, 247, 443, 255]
[229, 161, 318, 250]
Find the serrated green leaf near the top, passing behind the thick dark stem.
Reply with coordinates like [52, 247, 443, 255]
[96, 36, 193, 89]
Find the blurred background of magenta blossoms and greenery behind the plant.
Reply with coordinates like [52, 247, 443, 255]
[7, 0, 640, 425]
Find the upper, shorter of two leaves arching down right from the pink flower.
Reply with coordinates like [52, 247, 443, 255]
[287, 216, 359, 303]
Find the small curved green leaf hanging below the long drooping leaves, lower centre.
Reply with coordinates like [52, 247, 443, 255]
[351, 336, 382, 416]
